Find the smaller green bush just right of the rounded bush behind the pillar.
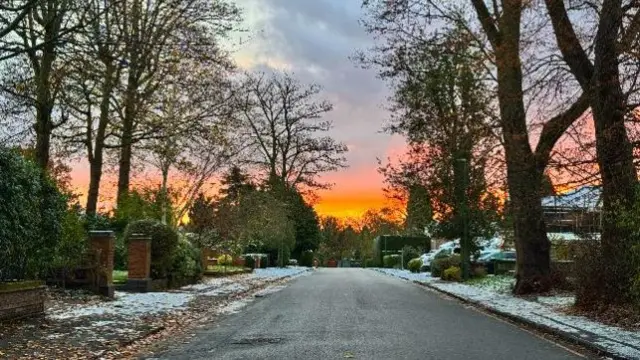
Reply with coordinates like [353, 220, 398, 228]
[169, 238, 202, 287]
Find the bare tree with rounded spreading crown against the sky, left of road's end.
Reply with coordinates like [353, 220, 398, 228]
[236, 74, 347, 189]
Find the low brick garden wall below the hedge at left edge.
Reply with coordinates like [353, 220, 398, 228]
[0, 283, 45, 321]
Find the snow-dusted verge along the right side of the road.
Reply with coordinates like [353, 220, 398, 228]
[376, 269, 640, 359]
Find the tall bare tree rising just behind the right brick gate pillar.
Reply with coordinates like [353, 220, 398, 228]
[111, 0, 239, 202]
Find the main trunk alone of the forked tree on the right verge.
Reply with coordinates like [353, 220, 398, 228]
[495, 1, 551, 294]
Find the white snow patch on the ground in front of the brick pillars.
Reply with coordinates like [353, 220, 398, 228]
[49, 291, 194, 320]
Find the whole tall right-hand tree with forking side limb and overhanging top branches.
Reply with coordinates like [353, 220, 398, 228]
[363, 0, 589, 294]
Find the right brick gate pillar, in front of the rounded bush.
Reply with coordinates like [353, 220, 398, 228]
[126, 234, 152, 292]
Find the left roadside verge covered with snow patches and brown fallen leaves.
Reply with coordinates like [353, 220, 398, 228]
[0, 267, 309, 359]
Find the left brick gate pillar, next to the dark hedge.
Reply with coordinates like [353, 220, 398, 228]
[89, 230, 116, 298]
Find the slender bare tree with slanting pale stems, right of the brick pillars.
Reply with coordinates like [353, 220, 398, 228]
[141, 53, 240, 222]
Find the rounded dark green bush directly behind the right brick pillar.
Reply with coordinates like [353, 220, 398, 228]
[124, 220, 178, 279]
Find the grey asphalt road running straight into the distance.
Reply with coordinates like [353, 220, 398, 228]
[156, 269, 580, 360]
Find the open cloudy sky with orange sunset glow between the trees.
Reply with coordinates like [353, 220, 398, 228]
[226, 0, 404, 217]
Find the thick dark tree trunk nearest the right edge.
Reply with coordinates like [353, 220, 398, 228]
[591, 0, 637, 303]
